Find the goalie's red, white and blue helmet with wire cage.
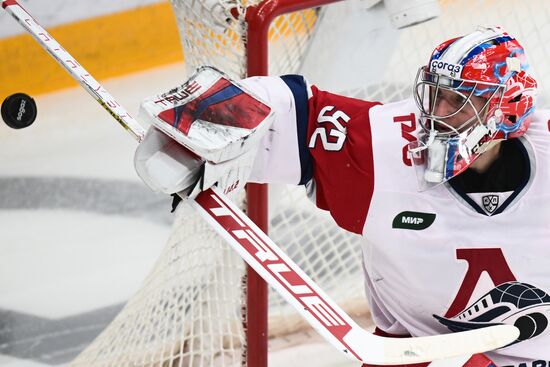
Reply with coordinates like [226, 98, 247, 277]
[408, 27, 537, 190]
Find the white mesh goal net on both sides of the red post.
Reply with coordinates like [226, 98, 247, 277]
[71, 0, 550, 366]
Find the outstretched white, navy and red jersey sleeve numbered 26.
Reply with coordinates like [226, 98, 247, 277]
[243, 75, 379, 234]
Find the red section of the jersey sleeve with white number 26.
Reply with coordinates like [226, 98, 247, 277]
[307, 81, 380, 234]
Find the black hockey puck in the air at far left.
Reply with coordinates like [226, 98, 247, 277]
[2, 93, 37, 129]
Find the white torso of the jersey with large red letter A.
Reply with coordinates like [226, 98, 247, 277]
[363, 101, 550, 366]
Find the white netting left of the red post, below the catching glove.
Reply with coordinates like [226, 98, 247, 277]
[71, 205, 248, 367]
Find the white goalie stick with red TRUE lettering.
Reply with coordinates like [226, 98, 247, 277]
[2, 0, 519, 367]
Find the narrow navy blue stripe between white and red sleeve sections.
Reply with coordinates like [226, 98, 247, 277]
[281, 75, 313, 185]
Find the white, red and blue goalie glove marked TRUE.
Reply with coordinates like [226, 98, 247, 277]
[134, 67, 273, 201]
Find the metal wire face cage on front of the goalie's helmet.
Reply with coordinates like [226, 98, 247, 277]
[408, 67, 506, 191]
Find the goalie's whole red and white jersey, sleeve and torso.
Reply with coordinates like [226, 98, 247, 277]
[244, 76, 550, 367]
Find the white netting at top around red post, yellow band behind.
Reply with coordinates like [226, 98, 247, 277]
[171, 0, 324, 78]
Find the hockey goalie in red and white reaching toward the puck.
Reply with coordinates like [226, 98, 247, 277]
[135, 27, 550, 367]
